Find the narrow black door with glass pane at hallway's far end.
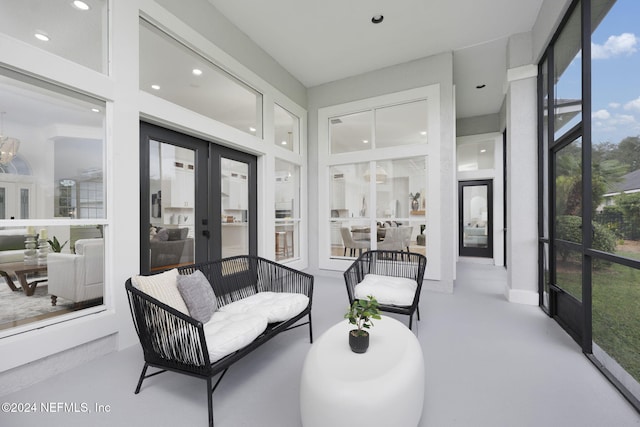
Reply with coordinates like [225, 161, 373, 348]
[458, 180, 493, 258]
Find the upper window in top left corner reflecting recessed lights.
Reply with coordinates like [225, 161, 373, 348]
[0, 0, 109, 74]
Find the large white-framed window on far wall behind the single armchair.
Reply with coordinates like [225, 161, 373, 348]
[319, 88, 438, 274]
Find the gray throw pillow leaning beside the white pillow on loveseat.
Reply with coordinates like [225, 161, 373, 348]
[178, 270, 218, 323]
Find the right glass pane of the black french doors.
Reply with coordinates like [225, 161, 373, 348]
[220, 157, 249, 258]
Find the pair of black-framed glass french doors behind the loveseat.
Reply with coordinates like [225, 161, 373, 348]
[140, 122, 258, 273]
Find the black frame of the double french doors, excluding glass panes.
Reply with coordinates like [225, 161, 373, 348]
[139, 122, 258, 274]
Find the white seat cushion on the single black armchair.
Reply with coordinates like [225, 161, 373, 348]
[355, 274, 418, 306]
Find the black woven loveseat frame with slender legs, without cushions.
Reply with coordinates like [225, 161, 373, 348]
[125, 256, 313, 426]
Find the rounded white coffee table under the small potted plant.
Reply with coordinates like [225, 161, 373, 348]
[300, 316, 424, 427]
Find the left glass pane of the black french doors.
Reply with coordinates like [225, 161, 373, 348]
[149, 140, 195, 270]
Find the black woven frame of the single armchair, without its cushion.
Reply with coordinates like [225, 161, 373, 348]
[344, 250, 427, 329]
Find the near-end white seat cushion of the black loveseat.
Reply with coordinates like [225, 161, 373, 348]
[204, 311, 267, 363]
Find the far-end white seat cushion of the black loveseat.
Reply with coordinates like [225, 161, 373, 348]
[218, 292, 309, 323]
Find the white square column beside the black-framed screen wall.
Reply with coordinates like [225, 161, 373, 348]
[505, 65, 538, 305]
